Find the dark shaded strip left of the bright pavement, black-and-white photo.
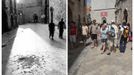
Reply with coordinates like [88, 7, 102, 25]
[2, 29, 18, 75]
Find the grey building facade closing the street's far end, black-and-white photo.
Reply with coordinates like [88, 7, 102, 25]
[17, 0, 49, 24]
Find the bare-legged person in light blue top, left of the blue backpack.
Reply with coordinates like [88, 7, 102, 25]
[100, 23, 108, 54]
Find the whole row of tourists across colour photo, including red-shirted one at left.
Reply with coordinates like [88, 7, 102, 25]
[69, 20, 132, 55]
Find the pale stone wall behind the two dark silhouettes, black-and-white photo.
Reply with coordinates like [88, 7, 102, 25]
[49, 0, 66, 24]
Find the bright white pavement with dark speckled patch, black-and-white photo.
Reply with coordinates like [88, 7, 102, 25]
[2, 24, 67, 75]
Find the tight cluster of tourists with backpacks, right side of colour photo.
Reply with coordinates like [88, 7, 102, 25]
[100, 21, 132, 55]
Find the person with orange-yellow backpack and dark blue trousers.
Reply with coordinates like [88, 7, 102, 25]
[120, 22, 129, 53]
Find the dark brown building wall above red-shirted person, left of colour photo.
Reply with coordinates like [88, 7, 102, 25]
[68, 0, 86, 25]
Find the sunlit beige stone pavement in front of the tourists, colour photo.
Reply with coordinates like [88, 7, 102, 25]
[69, 39, 132, 75]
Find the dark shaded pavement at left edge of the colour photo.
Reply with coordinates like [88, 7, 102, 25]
[68, 38, 91, 69]
